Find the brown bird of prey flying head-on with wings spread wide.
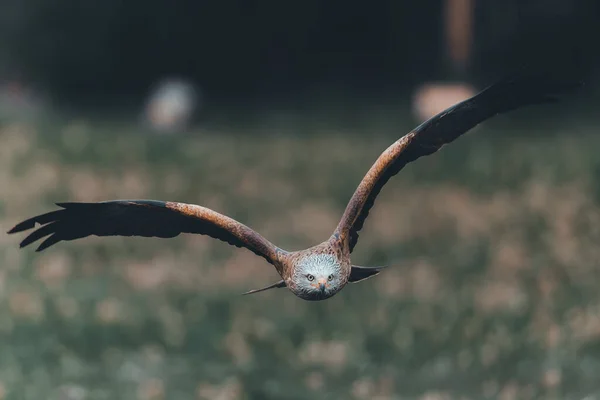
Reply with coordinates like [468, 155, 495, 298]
[8, 74, 578, 300]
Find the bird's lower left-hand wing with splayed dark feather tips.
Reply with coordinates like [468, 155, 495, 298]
[8, 200, 278, 266]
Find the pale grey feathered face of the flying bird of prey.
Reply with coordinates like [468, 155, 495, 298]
[289, 254, 344, 300]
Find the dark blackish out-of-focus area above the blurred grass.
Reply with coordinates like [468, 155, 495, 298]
[0, 0, 600, 105]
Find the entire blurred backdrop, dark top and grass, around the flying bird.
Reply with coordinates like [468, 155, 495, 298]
[0, 0, 600, 400]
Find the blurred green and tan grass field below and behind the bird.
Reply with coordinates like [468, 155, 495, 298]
[0, 110, 600, 400]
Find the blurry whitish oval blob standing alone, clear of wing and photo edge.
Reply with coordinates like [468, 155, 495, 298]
[145, 78, 201, 133]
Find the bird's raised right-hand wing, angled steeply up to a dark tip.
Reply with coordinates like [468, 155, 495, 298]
[336, 71, 580, 252]
